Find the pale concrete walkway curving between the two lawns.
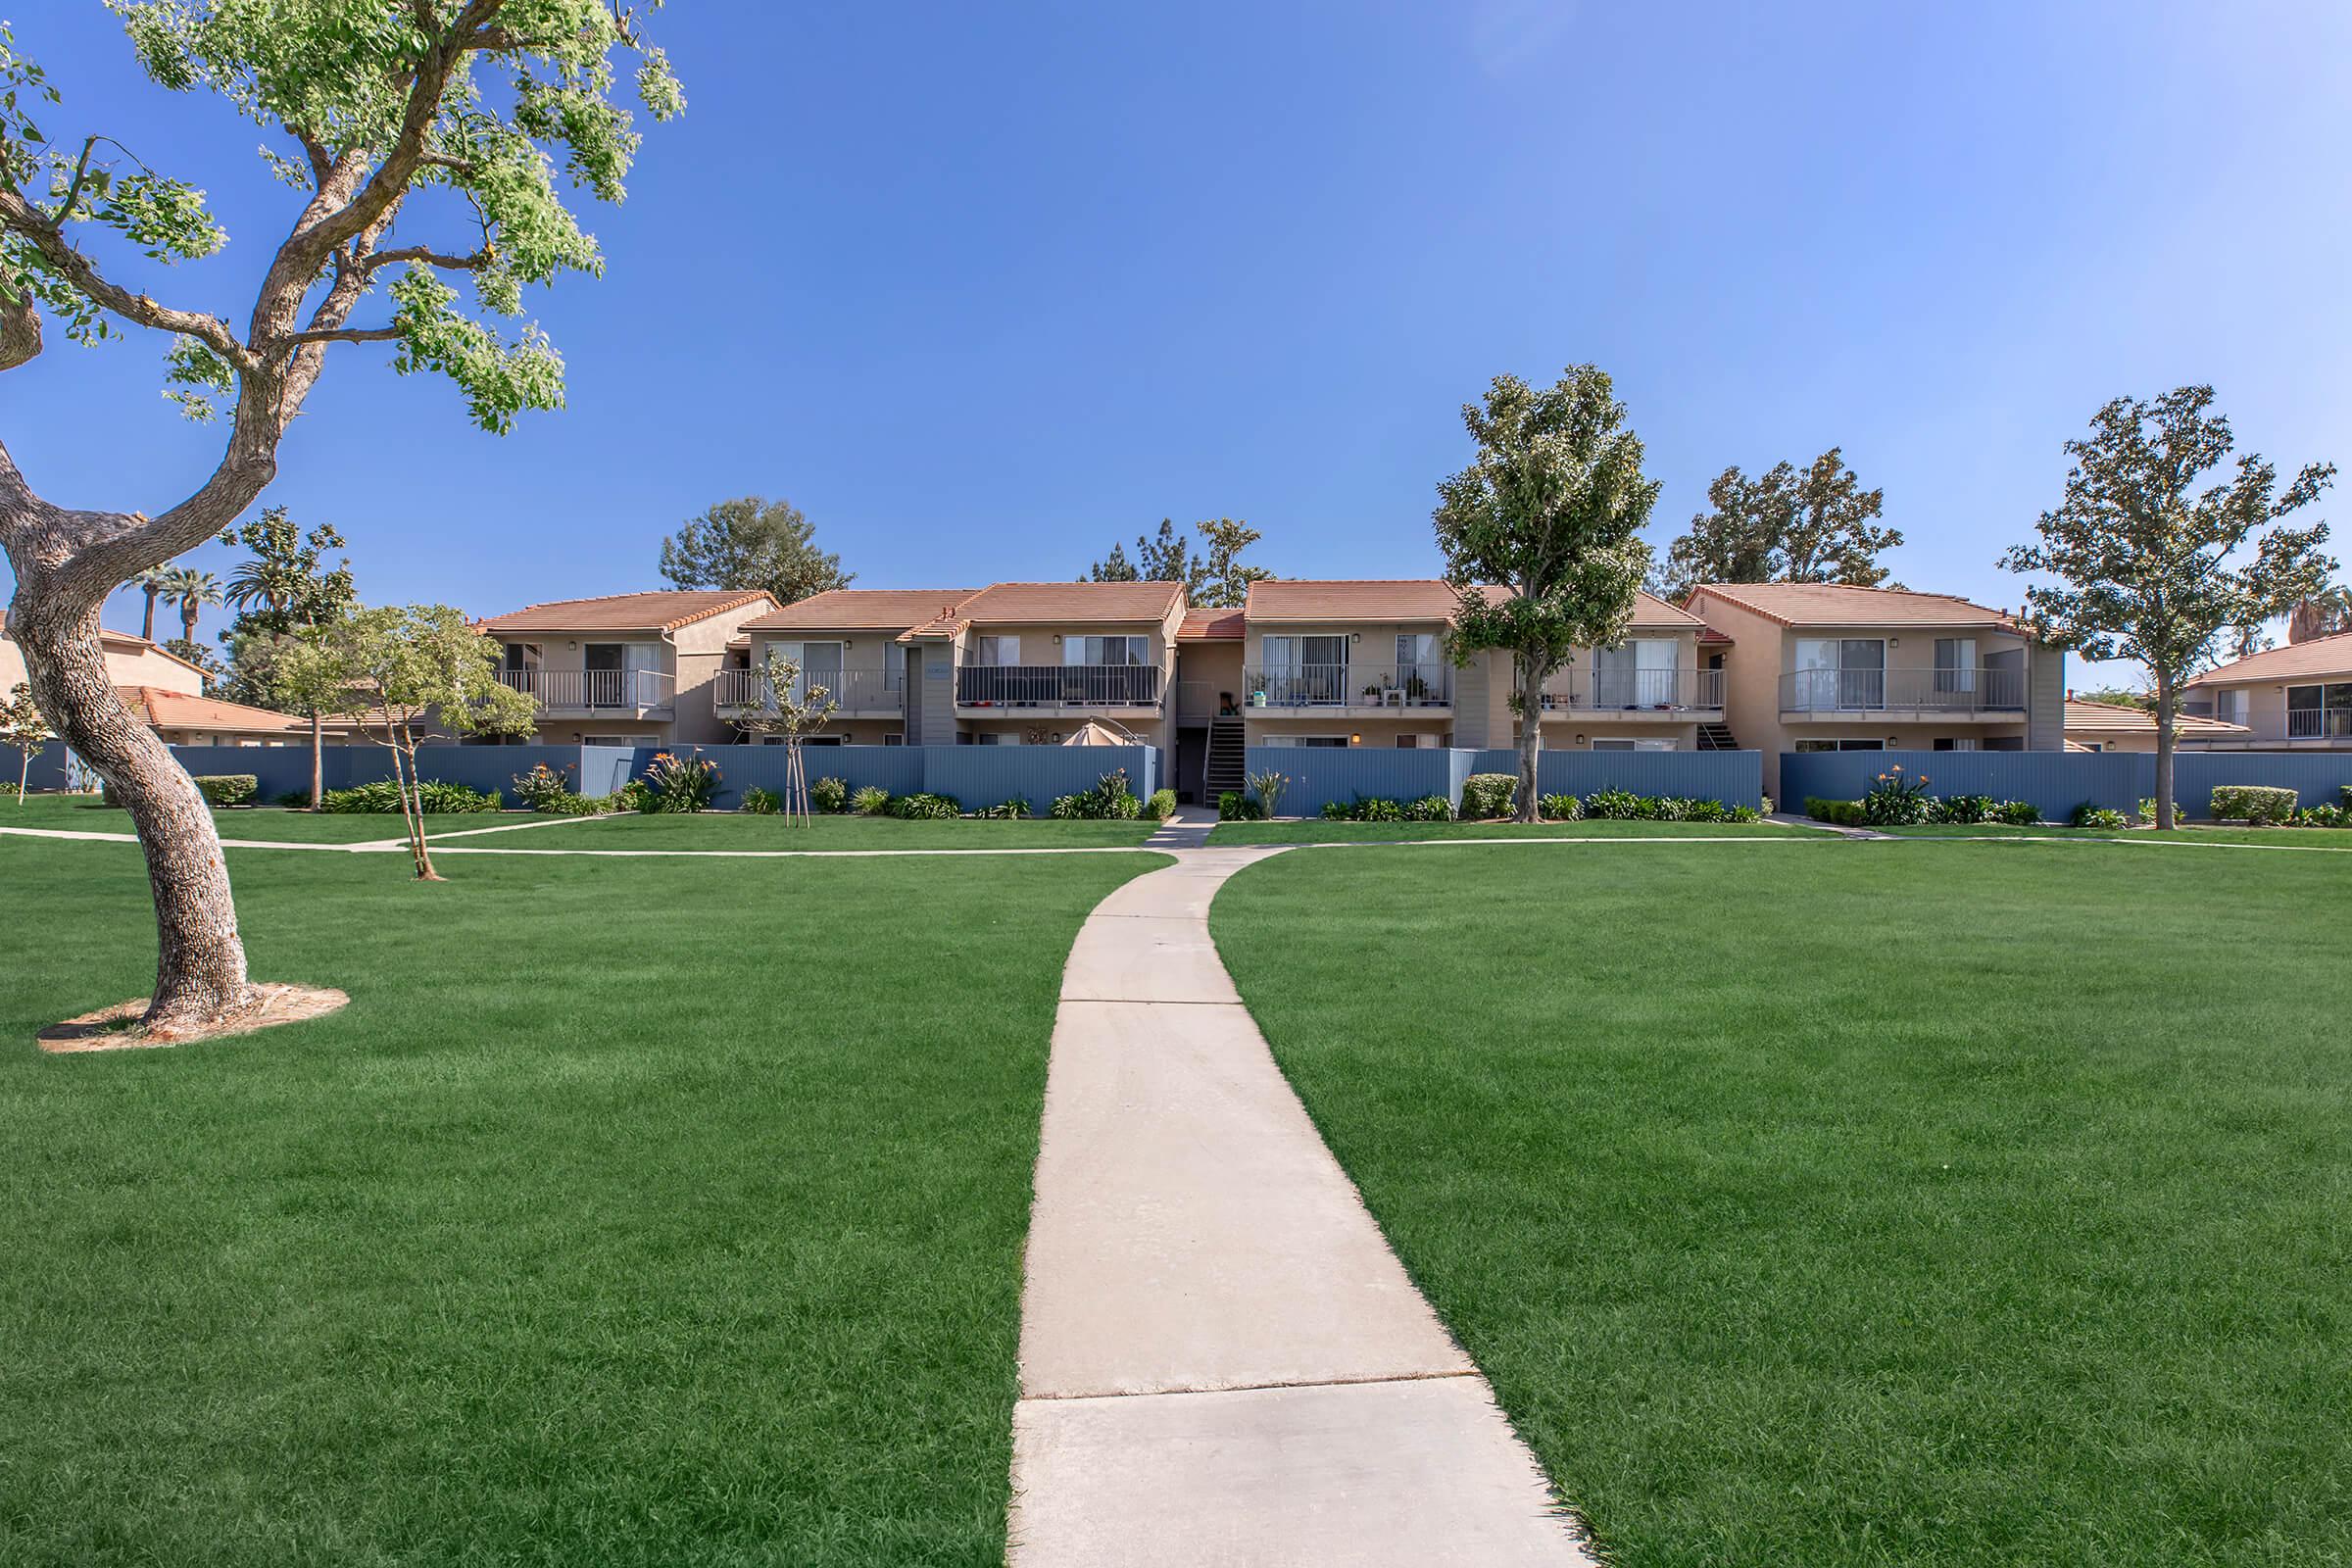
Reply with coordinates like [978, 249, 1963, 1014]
[1011, 849, 1592, 1568]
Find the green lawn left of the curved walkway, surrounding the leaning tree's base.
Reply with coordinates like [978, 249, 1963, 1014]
[0, 818, 1162, 1568]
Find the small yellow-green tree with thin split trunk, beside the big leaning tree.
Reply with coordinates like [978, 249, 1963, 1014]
[306, 604, 539, 882]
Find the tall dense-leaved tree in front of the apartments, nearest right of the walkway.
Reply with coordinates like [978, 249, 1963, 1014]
[1435, 365, 1658, 823]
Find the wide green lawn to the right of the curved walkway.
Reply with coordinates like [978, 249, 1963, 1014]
[1211, 835, 2352, 1568]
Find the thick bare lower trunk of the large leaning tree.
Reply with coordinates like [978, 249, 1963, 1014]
[10, 592, 254, 1027]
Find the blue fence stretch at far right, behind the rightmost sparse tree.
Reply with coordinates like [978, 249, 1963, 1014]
[1781, 753, 2352, 820]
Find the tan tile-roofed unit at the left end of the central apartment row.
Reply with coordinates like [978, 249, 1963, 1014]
[482, 590, 781, 745]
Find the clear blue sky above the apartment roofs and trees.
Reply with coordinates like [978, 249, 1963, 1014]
[0, 0, 2352, 682]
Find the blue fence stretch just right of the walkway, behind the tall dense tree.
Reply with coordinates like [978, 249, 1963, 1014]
[1247, 745, 1764, 815]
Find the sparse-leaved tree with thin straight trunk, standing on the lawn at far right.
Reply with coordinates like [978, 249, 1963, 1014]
[2001, 385, 2335, 827]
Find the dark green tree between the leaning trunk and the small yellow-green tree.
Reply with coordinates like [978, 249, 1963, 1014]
[221, 506, 358, 811]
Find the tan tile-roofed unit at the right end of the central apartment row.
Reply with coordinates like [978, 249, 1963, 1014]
[1684, 583, 2065, 795]
